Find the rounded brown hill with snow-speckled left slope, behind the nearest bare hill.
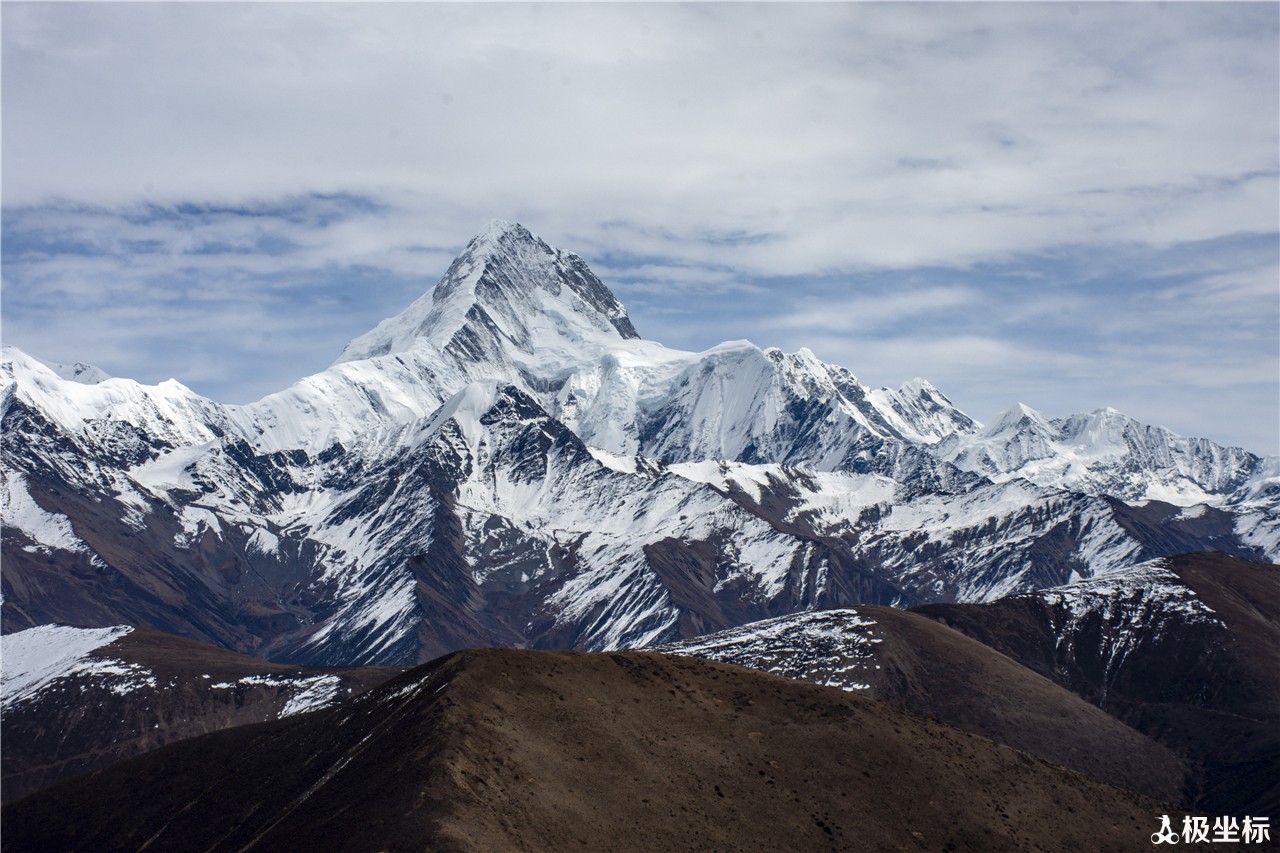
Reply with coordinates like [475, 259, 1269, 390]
[659, 596, 1187, 802]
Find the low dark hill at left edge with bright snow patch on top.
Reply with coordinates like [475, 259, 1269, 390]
[0, 625, 402, 802]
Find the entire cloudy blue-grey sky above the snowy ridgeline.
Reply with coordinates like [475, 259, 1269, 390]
[0, 0, 1280, 453]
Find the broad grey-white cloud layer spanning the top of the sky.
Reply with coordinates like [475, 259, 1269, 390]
[4, 4, 1276, 261]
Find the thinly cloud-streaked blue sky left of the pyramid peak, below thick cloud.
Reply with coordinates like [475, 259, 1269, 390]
[4, 197, 440, 402]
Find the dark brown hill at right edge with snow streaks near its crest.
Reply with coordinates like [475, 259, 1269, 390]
[919, 553, 1280, 815]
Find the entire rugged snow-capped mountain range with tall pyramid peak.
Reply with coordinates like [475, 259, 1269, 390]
[0, 223, 1280, 663]
